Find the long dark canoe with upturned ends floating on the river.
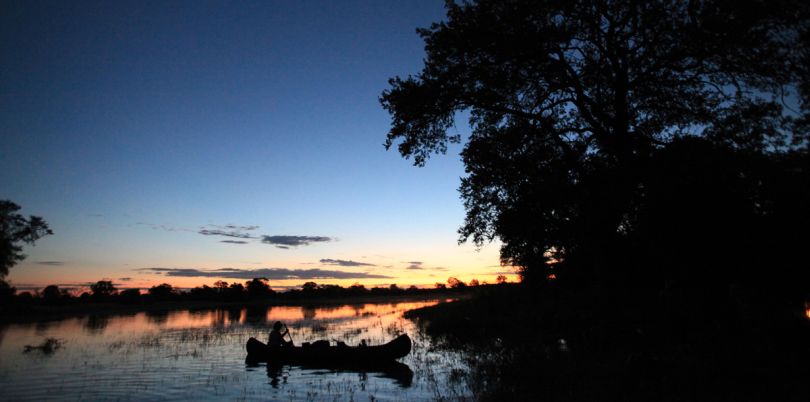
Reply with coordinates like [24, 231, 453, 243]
[246, 334, 411, 363]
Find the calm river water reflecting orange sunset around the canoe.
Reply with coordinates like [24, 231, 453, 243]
[0, 300, 471, 401]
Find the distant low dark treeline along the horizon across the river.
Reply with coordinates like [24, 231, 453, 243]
[4, 277, 486, 306]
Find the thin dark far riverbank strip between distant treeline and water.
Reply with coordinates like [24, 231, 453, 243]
[0, 290, 472, 324]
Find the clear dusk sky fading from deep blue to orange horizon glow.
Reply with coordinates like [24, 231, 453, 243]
[0, 0, 511, 289]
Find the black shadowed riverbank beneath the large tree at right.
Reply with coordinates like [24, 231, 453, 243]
[406, 287, 810, 401]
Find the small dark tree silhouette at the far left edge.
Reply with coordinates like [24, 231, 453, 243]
[0, 200, 53, 279]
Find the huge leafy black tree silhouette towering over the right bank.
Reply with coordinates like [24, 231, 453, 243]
[381, 0, 810, 298]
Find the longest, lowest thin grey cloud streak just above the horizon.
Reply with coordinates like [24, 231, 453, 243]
[137, 268, 391, 280]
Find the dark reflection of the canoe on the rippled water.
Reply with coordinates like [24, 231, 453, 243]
[267, 361, 413, 388]
